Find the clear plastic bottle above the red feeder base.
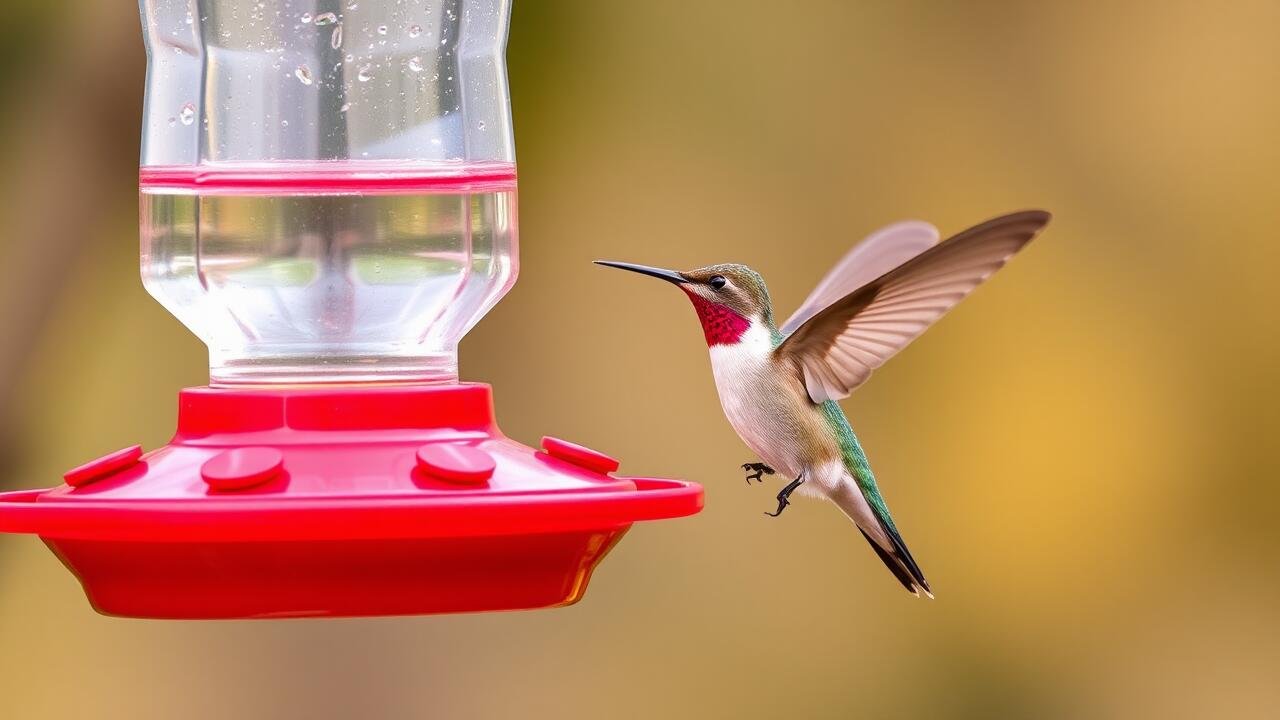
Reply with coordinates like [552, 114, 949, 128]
[140, 0, 517, 384]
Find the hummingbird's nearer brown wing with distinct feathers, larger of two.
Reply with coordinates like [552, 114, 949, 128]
[774, 210, 1050, 402]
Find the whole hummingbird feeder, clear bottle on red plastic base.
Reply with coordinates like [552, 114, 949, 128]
[0, 0, 703, 619]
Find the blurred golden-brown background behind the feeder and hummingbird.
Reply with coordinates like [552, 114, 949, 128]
[0, 0, 1280, 719]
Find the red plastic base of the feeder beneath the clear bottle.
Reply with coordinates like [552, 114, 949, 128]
[0, 384, 703, 619]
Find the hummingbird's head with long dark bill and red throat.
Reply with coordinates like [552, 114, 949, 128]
[595, 260, 774, 346]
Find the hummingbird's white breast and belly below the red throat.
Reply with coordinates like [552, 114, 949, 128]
[710, 323, 801, 477]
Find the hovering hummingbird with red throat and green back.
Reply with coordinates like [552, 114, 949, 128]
[596, 210, 1050, 598]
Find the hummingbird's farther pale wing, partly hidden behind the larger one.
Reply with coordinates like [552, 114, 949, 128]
[781, 220, 938, 334]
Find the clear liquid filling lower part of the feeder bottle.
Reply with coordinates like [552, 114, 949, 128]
[141, 161, 518, 384]
